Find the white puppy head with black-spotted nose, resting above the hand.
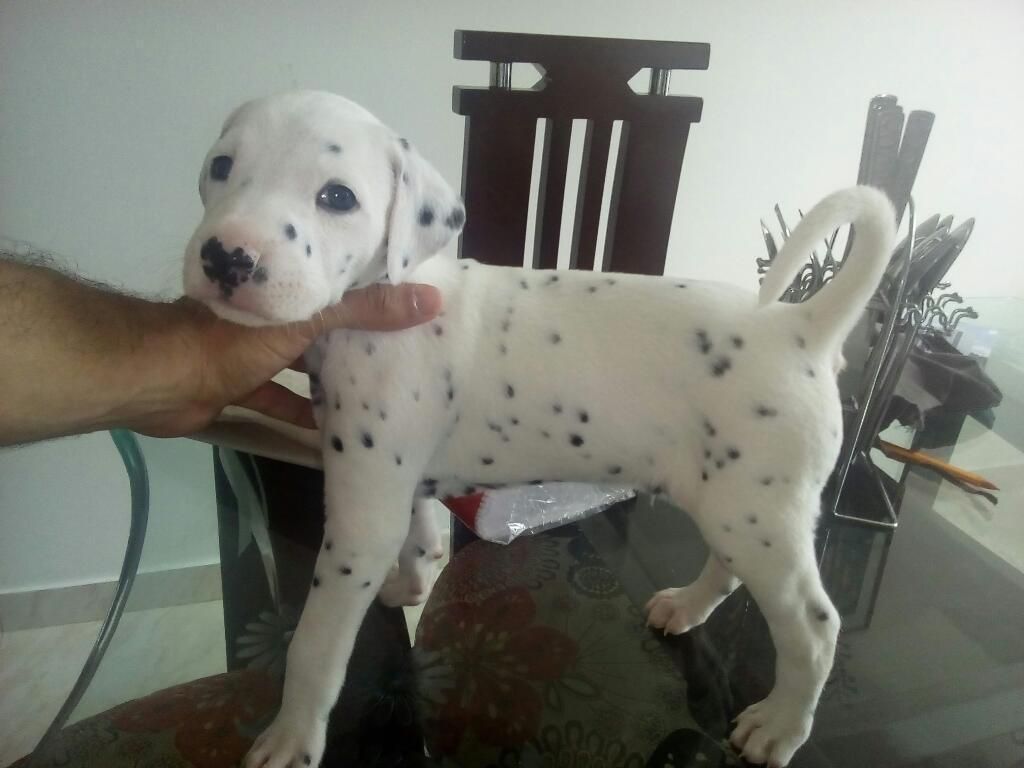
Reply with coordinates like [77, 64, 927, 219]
[184, 91, 465, 325]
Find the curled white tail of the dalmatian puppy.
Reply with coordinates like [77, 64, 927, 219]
[758, 186, 896, 339]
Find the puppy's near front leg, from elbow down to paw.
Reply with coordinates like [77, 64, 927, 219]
[246, 454, 415, 768]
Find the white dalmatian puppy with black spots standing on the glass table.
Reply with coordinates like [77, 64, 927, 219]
[184, 92, 895, 768]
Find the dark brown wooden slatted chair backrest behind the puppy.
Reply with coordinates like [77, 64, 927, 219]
[453, 31, 711, 274]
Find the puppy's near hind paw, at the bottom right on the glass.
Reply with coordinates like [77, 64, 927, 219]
[729, 696, 813, 768]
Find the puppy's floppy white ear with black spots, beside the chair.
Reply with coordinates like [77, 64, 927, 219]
[387, 138, 466, 285]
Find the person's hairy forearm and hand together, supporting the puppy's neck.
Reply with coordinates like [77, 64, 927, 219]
[0, 255, 440, 445]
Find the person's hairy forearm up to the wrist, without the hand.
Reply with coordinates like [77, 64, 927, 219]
[0, 258, 194, 444]
